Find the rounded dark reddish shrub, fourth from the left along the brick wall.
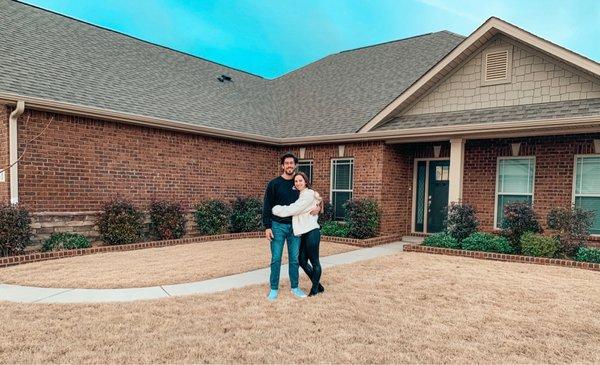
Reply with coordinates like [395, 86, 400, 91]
[150, 201, 187, 240]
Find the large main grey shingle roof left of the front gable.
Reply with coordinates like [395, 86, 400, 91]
[0, 0, 464, 137]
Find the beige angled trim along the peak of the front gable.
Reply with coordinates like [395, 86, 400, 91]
[358, 17, 600, 133]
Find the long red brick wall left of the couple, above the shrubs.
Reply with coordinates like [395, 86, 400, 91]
[19, 110, 278, 212]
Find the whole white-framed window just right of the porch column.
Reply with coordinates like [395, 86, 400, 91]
[494, 157, 535, 228]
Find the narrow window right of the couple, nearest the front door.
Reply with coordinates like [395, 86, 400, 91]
[331, 159, 354, 219]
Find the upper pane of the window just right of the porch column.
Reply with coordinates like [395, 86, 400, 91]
[498, 158, 534, 194]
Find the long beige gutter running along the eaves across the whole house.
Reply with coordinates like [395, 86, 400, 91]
[0, 92, 600, 147]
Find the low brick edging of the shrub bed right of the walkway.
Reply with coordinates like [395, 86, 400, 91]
[404, 245, 600, 271]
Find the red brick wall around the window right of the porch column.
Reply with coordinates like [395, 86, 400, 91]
[463, 133, 600, 231]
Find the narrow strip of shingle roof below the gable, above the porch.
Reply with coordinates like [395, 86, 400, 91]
[374, 99, 600, 131]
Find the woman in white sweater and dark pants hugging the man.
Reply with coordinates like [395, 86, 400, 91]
[272, 172, 325, 297]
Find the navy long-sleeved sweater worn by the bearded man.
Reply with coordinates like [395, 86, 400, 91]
[263, 176, 300, 228]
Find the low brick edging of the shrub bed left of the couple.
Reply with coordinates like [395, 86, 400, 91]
[0, 232, 264, 268]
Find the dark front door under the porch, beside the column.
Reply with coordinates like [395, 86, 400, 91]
[427, 160, 450, 233]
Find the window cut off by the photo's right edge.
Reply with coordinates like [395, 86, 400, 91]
[573, 156, 600, 234]
